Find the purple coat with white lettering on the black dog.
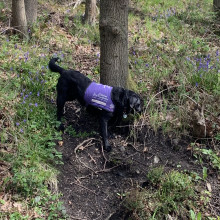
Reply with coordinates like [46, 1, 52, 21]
[84, 82, 115, 112]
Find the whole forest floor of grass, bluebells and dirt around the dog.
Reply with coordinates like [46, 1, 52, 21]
[0, 0, 220, 220]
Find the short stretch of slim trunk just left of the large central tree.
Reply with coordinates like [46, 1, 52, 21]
[84, 0, 96, 25]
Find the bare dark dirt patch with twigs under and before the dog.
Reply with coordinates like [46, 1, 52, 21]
[58, 99, 220, 220]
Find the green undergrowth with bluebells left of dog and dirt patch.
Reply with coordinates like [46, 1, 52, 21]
[0, 36, 65, 219]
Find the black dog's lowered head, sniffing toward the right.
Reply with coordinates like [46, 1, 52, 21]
[128, 90, 143, 113]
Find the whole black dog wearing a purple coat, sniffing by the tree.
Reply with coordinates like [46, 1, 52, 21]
[49, 58, 142, 151]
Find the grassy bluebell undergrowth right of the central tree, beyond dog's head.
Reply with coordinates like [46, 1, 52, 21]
[129, 0, 220, 139]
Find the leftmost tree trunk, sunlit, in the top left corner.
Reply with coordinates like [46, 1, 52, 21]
[12, 0, 28, 37]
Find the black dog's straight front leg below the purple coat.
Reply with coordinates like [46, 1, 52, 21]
[100, 112, 112, 152]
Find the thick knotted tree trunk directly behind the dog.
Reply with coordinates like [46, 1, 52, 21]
[99, 0, 129, 88]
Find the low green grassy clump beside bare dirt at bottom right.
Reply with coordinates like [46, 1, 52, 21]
[126, 168, 197, 219]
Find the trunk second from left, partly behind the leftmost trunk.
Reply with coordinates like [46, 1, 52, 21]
[24, 0, 37, 25]
